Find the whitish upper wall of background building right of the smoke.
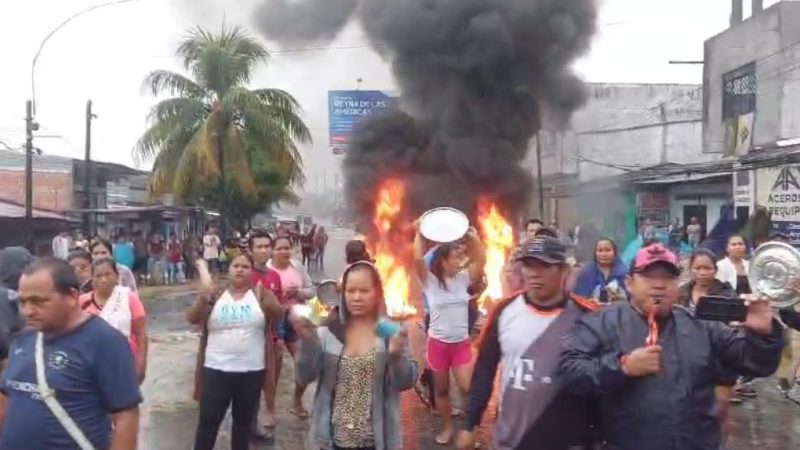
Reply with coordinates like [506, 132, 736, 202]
[526, 83, 715, 181]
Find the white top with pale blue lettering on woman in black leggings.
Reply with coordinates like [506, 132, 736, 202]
[205, 290, 267, 372]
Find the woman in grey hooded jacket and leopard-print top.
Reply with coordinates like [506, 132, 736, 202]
[292, 261, 418, 450]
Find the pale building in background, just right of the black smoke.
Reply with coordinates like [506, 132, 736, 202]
[526, 83, 730, 242]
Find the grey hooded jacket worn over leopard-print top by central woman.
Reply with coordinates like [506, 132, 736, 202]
[296, 262, 418, 450]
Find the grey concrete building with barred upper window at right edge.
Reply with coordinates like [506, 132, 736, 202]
[703, 0, 800, 245]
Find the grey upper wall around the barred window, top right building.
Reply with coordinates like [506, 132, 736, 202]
[703, 1, 800, 153]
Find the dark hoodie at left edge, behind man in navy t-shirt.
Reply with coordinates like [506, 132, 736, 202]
[0, 247, 33, 360]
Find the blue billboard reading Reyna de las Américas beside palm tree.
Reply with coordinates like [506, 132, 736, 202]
[328, 91, 394, 154]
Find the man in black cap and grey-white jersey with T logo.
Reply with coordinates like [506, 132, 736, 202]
[458, 236, 595, 450]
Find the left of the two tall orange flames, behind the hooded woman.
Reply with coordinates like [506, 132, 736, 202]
[370, 179, 417, 318]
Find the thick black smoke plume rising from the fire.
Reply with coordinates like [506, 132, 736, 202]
[253, 0, 596, 227]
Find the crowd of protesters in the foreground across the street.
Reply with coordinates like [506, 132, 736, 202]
[0, 215, 800, 450]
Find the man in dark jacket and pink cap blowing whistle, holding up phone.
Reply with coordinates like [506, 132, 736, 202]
[561, 244, 782, 450]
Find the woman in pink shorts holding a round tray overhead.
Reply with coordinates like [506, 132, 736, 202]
[414, 223, 486, 445]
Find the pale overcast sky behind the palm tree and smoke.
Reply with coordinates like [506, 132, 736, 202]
[0, 0, 777, 190]
